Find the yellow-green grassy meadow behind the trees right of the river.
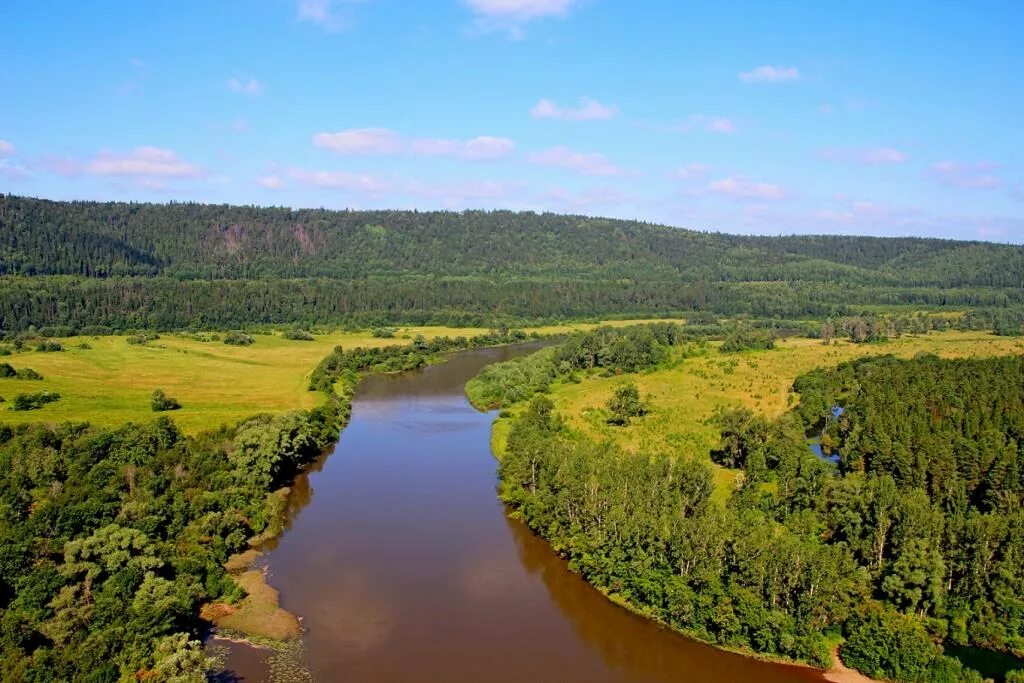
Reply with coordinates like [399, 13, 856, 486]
[492, 331, 1024, 496]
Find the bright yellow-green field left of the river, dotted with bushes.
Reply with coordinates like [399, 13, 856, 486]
[0, 321, 663, 432]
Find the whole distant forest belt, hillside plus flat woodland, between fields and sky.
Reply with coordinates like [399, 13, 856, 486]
[0, 196, 1024, 330]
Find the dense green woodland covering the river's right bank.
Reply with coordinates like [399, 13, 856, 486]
[483, 331, 1024, 681]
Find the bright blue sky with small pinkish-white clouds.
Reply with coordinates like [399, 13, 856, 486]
[0, 0, 1024, 244]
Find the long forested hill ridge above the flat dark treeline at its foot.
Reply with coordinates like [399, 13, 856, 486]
[0, 196, 1024, 288]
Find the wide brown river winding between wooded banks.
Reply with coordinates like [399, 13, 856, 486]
[216, 347, 823, 683]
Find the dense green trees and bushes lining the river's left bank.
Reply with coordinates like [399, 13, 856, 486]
[0, 331, 548, 682]
